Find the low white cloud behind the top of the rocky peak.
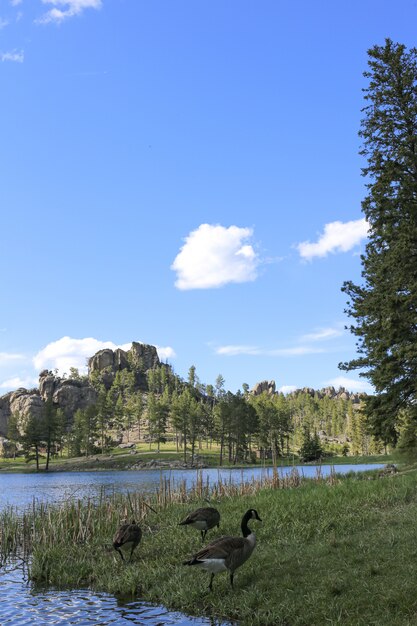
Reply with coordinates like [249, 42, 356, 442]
[33, 337, 175, 375]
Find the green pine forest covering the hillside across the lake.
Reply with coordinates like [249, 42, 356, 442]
[8, 364, 382, 465]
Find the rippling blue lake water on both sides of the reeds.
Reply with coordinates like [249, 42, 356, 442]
[0, 464, 383, 626]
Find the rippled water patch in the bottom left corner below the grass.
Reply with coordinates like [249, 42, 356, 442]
[0, 564, 232, 626]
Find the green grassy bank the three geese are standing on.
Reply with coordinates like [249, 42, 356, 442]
[2, 471, 417, 626]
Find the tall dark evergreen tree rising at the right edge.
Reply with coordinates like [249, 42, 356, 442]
[340, 39, 417, 444]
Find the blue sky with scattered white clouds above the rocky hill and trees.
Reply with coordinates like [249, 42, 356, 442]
[0, 0, 417, 394]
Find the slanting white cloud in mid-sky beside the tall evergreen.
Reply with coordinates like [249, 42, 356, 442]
[296, 218, 369, 260]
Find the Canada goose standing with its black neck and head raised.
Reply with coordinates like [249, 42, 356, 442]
[183, 509, 262, 591]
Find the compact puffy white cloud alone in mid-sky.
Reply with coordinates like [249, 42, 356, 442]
[171, 224, 259, 290]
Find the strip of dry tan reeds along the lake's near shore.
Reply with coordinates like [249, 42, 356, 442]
[0, 467, 338, 566]
